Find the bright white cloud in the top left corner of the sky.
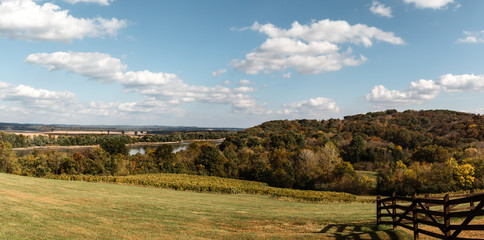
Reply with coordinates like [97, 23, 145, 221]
[0, 0, 127, 42]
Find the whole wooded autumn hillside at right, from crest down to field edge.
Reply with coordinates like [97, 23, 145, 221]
[221, 110, 484, 194]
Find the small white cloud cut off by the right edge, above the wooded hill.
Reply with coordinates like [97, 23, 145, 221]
[438, 74, 484, 92]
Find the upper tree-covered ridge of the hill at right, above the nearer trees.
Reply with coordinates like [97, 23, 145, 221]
[228, 110, 484, 151]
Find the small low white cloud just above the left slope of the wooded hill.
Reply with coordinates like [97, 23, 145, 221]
[281, 97, 339, 118]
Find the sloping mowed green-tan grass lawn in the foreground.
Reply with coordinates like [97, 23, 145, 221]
[0, 174, 411, 239]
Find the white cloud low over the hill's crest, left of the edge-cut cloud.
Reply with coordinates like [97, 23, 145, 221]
[366, 79, 440, 106]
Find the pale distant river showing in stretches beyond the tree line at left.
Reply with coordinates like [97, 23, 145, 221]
[13, 139, 223, 157]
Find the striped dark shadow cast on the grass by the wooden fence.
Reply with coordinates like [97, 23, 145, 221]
[318, 223, 411, 240]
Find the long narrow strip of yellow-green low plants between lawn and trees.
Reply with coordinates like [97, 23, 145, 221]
[45, 173, 356, 203]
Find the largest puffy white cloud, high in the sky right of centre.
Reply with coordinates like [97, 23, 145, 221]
[231, 19, 405, 74]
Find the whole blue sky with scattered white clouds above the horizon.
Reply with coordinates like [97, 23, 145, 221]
[0, 0, 484, 128]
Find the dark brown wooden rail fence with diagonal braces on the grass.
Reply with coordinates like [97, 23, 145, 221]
[376, 192, 484, 240]
